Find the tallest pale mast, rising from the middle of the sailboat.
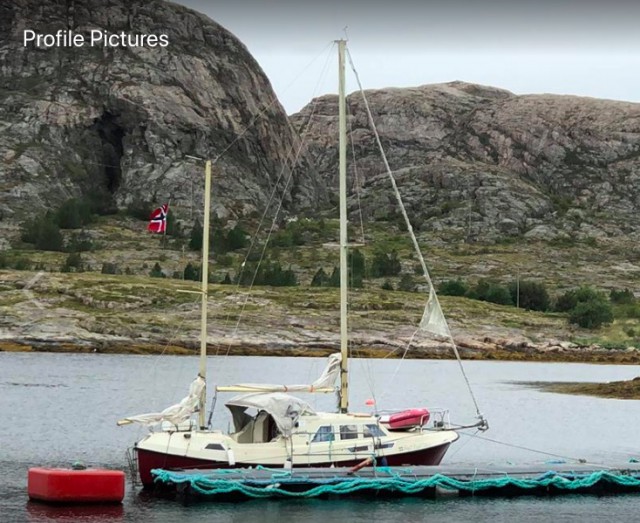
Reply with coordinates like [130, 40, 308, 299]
[338, 40, 349, 413]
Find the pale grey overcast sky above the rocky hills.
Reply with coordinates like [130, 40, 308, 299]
[174, 0, 640, 113]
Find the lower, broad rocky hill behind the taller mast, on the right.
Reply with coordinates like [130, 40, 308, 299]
[291, 82, 640, 245]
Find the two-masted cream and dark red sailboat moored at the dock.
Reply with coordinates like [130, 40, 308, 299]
[118, 40, 484, 486]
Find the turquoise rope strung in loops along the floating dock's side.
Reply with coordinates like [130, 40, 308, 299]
[151, 469, 640, 498]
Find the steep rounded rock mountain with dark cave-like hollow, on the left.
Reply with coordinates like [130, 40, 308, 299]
[0, 0, 324, 229]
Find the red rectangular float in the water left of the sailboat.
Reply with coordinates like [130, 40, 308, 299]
[27, 468, 124, 503]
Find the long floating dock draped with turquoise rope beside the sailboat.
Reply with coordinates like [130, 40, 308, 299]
[151, 462, 640, 501]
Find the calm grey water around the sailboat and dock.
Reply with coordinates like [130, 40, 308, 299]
[0, 353, 640, 523]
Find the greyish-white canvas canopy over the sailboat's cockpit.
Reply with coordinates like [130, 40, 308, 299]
[225, 392, 315, 437]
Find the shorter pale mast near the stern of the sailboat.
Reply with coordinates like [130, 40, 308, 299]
[198, 160, 211, 429]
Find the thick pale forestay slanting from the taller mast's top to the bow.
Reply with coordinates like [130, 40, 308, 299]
[347, 48, 488, 429]
